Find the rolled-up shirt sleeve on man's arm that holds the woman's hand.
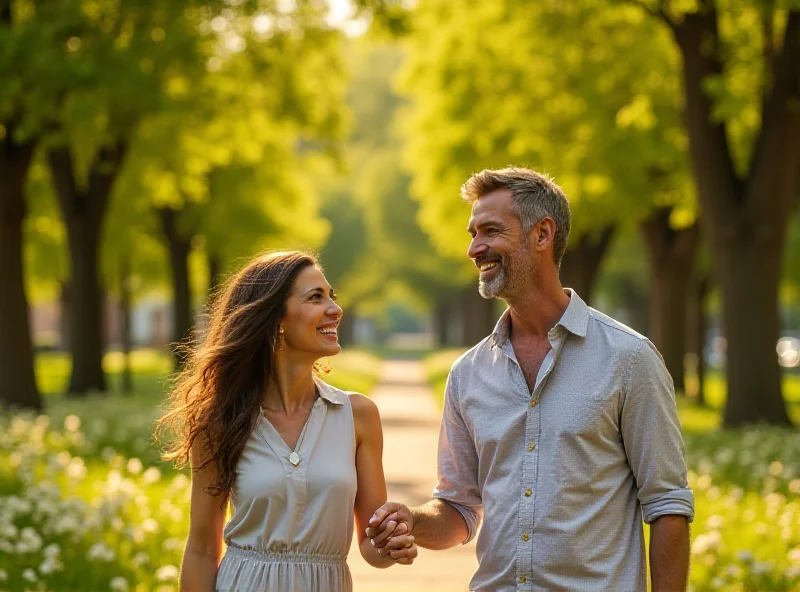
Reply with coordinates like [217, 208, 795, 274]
[433, 370, 483, 544]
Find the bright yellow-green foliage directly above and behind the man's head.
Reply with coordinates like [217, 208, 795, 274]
[403, 0, 693, 266]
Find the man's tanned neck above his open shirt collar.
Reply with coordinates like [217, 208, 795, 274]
[508, 283, 570, 339]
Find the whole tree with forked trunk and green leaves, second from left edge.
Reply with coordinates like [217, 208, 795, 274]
[33, 0, 213, 395]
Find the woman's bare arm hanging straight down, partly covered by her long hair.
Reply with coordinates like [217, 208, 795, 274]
[181, 437, 228, 592]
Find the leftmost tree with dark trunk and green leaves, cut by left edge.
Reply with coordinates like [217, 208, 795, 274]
[0, 0, 77, 408]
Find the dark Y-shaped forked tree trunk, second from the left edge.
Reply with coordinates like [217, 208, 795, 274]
[48, 142, 126, 396]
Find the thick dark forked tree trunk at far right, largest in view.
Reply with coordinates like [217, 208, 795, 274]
[670, 9, 800, 426]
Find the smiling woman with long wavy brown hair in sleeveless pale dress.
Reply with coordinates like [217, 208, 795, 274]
[159, 252, 417, 592]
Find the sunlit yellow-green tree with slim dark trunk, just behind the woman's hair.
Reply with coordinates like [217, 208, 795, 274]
[122, 5, 341, 365]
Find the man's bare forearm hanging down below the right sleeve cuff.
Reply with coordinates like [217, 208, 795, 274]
[650, 515, 689, 592]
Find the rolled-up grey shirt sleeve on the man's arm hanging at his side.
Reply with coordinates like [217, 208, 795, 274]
[621, 340, 694, 524]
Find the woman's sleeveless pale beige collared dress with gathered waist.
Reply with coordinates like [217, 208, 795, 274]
[216, 380, 357, 592]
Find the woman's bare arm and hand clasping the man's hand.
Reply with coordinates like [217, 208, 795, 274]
[350, 394, 417, 568]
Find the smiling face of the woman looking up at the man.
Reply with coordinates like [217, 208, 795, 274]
[281, 266, 342, 360]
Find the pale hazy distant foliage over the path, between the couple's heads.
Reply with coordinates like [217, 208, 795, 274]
[315, 39, 460, 315]
